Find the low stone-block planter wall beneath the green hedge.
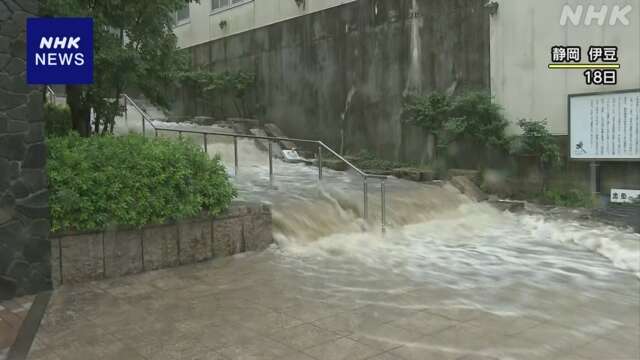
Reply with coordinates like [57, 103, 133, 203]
[51, 204, 273, 286]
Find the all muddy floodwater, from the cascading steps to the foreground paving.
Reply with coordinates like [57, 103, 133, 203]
[35, 119, 640, 360]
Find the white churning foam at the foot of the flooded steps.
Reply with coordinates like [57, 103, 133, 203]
[276, 204, 640, 289]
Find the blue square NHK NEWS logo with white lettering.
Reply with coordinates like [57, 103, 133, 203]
[27, 18, 93, 84]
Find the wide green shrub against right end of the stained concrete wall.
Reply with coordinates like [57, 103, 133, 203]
[403, 92, 509, 158]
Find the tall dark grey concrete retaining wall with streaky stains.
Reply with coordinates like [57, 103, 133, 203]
[174, 0, 489, 161]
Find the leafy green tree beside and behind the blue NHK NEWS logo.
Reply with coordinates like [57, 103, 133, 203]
[40, 0, 191, 136]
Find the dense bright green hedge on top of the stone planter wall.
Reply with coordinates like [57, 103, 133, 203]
[47, 134, 237, 232]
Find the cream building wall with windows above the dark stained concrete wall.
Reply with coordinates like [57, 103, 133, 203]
[175, 0, 355, 48]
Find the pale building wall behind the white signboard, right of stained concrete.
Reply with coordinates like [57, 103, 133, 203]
[491, 0, 640, 135]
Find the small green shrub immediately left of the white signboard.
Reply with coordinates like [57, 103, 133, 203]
[515, 119, 560, 192]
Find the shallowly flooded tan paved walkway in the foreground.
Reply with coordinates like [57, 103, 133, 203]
[29, 251, 640, 360]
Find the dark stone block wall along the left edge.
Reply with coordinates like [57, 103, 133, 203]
[0, 0, 51, 299]
